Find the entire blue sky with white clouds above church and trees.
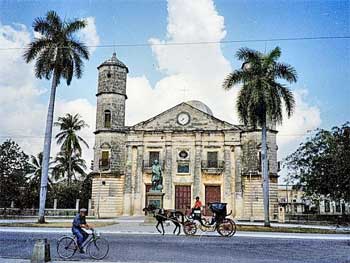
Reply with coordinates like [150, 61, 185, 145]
[0, 0, 350, 183]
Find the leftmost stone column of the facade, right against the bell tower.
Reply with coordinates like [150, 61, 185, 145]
[123, 145, 132, 215]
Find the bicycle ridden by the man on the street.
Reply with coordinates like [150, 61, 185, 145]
[57, 229, 109, 260]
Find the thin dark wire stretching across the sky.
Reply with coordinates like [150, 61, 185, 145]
[0, 36, 350, 50]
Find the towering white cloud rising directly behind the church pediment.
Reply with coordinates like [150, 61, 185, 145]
[127, 0, 237, 124]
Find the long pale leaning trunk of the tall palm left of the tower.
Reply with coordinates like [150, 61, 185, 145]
[38, 71, 57, 223]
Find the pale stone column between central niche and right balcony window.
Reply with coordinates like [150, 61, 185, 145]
[193, 132, 202, 197]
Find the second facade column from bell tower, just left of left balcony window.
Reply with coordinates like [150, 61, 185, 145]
[134, 145, 143, 215]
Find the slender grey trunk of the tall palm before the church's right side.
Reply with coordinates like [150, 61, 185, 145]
[261, 123, 270, 227]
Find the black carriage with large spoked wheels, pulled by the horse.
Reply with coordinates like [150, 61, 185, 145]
[183, 202, 236, 237]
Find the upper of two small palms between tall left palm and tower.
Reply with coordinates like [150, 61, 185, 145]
[55, 113, 89, 180]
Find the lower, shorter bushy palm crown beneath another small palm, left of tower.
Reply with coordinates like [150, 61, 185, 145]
[52, 151, 87, 185]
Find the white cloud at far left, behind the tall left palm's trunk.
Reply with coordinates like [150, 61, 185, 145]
[0, 23, 95, 165]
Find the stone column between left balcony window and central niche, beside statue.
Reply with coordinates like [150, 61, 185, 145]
[163, 132, 173, 208]
